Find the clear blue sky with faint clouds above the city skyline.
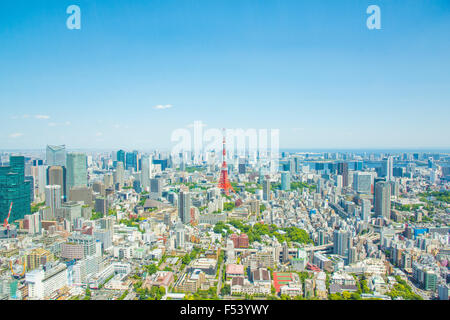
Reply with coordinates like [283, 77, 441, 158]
[0, 0, 450, 149]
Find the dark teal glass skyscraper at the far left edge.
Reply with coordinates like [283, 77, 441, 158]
[0, 156, 31, 223]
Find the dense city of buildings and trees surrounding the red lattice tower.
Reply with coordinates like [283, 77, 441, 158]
[0, 144, 450, 300]
